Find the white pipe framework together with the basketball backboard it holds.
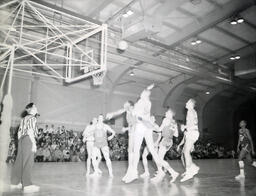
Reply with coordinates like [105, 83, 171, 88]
[0, 0, 107, 83]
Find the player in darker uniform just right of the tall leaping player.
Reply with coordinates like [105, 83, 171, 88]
[152, 109, 179, 182]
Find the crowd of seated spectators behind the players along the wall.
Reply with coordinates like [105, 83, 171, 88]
[6, 125, 235, 162]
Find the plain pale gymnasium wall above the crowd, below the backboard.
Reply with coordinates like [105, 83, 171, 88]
[1, 74, 168, 131]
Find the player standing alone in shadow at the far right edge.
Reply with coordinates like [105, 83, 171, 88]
[235, 120, 256, 180]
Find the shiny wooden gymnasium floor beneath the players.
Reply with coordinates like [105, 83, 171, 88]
[3, 159, 256, 196]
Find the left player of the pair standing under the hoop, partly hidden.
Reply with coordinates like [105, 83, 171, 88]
[83, 118, 97, 176]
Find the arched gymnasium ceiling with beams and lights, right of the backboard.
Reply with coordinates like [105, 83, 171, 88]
[1, 0, 256, 105]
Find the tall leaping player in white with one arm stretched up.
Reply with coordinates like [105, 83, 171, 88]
[125, 84, 180, 183]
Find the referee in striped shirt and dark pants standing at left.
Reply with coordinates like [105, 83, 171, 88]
[11, 103, 40, 193]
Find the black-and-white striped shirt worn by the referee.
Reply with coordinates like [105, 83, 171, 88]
[18, 115, 38, 139]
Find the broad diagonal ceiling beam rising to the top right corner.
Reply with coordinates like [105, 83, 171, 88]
[166, 0, 254, 48]
